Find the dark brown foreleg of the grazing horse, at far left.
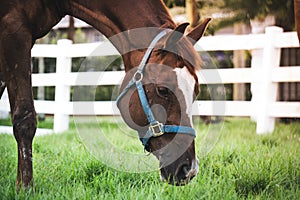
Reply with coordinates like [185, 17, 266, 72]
[3, 34, 37, 189]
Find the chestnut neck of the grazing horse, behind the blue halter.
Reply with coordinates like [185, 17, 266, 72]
[67, 0, 175, 70]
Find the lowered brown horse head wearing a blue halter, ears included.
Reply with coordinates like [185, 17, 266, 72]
[117, 19, 210, 185]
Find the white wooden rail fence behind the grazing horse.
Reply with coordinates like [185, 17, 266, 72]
[0, 27, 300, 134]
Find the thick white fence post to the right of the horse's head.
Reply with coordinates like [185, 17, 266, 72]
[254, 26, 283, 134]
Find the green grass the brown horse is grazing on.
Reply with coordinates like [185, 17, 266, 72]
[0, 118, 300, 200]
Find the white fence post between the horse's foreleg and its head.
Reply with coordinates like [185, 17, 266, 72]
[53, 39, 72, 133]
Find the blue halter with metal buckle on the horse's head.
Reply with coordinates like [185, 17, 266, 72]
[116, 30, 196, 152]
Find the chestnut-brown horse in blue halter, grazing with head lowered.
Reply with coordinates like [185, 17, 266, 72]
[0, 0, 210, 189]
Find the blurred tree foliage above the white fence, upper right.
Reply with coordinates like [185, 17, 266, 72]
[164, 0, 295, 34]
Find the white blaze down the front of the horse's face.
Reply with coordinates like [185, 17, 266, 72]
[174, 67, 196, 126]
